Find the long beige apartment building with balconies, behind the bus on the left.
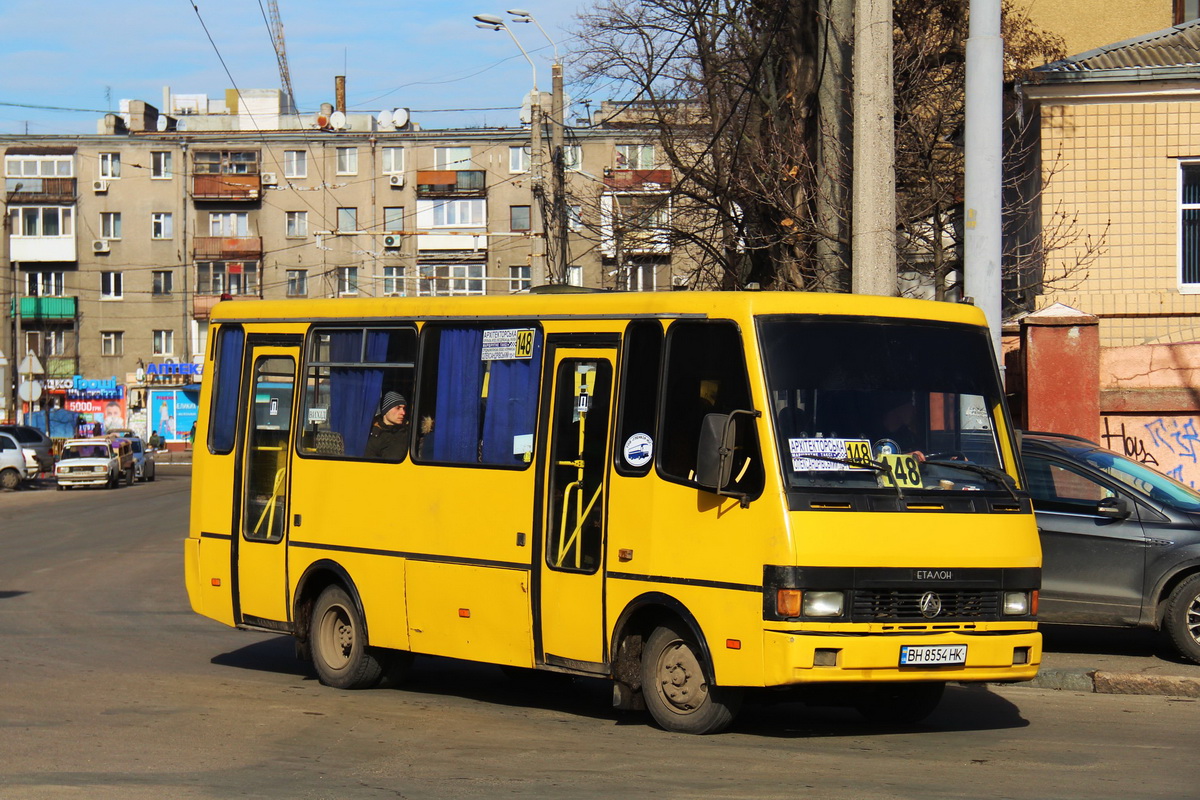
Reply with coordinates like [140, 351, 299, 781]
[0, 90, 689, 433]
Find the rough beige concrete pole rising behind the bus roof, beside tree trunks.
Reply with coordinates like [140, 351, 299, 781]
[851, 0, 896, 296]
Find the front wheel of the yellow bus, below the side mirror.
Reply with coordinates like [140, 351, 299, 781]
[642, 622, 742, 734]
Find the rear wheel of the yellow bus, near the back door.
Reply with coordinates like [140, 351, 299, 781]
[308, 585, 388, 688]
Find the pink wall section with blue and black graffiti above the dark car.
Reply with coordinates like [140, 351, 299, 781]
[1100, 415, 1200, 488]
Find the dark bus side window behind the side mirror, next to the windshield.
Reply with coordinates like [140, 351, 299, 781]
[659, 320, 763, 498]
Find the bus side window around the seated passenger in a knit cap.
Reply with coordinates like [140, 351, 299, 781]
[298, 327, 416, 461]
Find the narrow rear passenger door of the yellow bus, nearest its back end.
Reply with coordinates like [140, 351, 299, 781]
[235, 345, 300, 628]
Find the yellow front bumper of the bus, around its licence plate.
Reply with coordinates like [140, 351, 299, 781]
[763, 631, 1042, 686]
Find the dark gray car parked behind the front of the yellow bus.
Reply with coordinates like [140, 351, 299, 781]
[1021, 433, 1200, 663]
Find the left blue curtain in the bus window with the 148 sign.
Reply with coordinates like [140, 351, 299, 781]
[428, 329, 484, 464]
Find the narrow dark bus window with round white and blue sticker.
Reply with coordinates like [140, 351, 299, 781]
[613, 320, 662, 475]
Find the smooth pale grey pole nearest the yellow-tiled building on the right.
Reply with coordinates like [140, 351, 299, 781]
[962, 0, 1004, 363]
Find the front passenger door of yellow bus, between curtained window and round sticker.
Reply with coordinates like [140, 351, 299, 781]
[536, 345, 616, 672]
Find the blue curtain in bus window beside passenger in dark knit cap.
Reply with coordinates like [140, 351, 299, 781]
[329, 330, 388, 456]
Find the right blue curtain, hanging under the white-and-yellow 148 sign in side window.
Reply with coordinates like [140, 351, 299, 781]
[481, 331, 541, 465]
